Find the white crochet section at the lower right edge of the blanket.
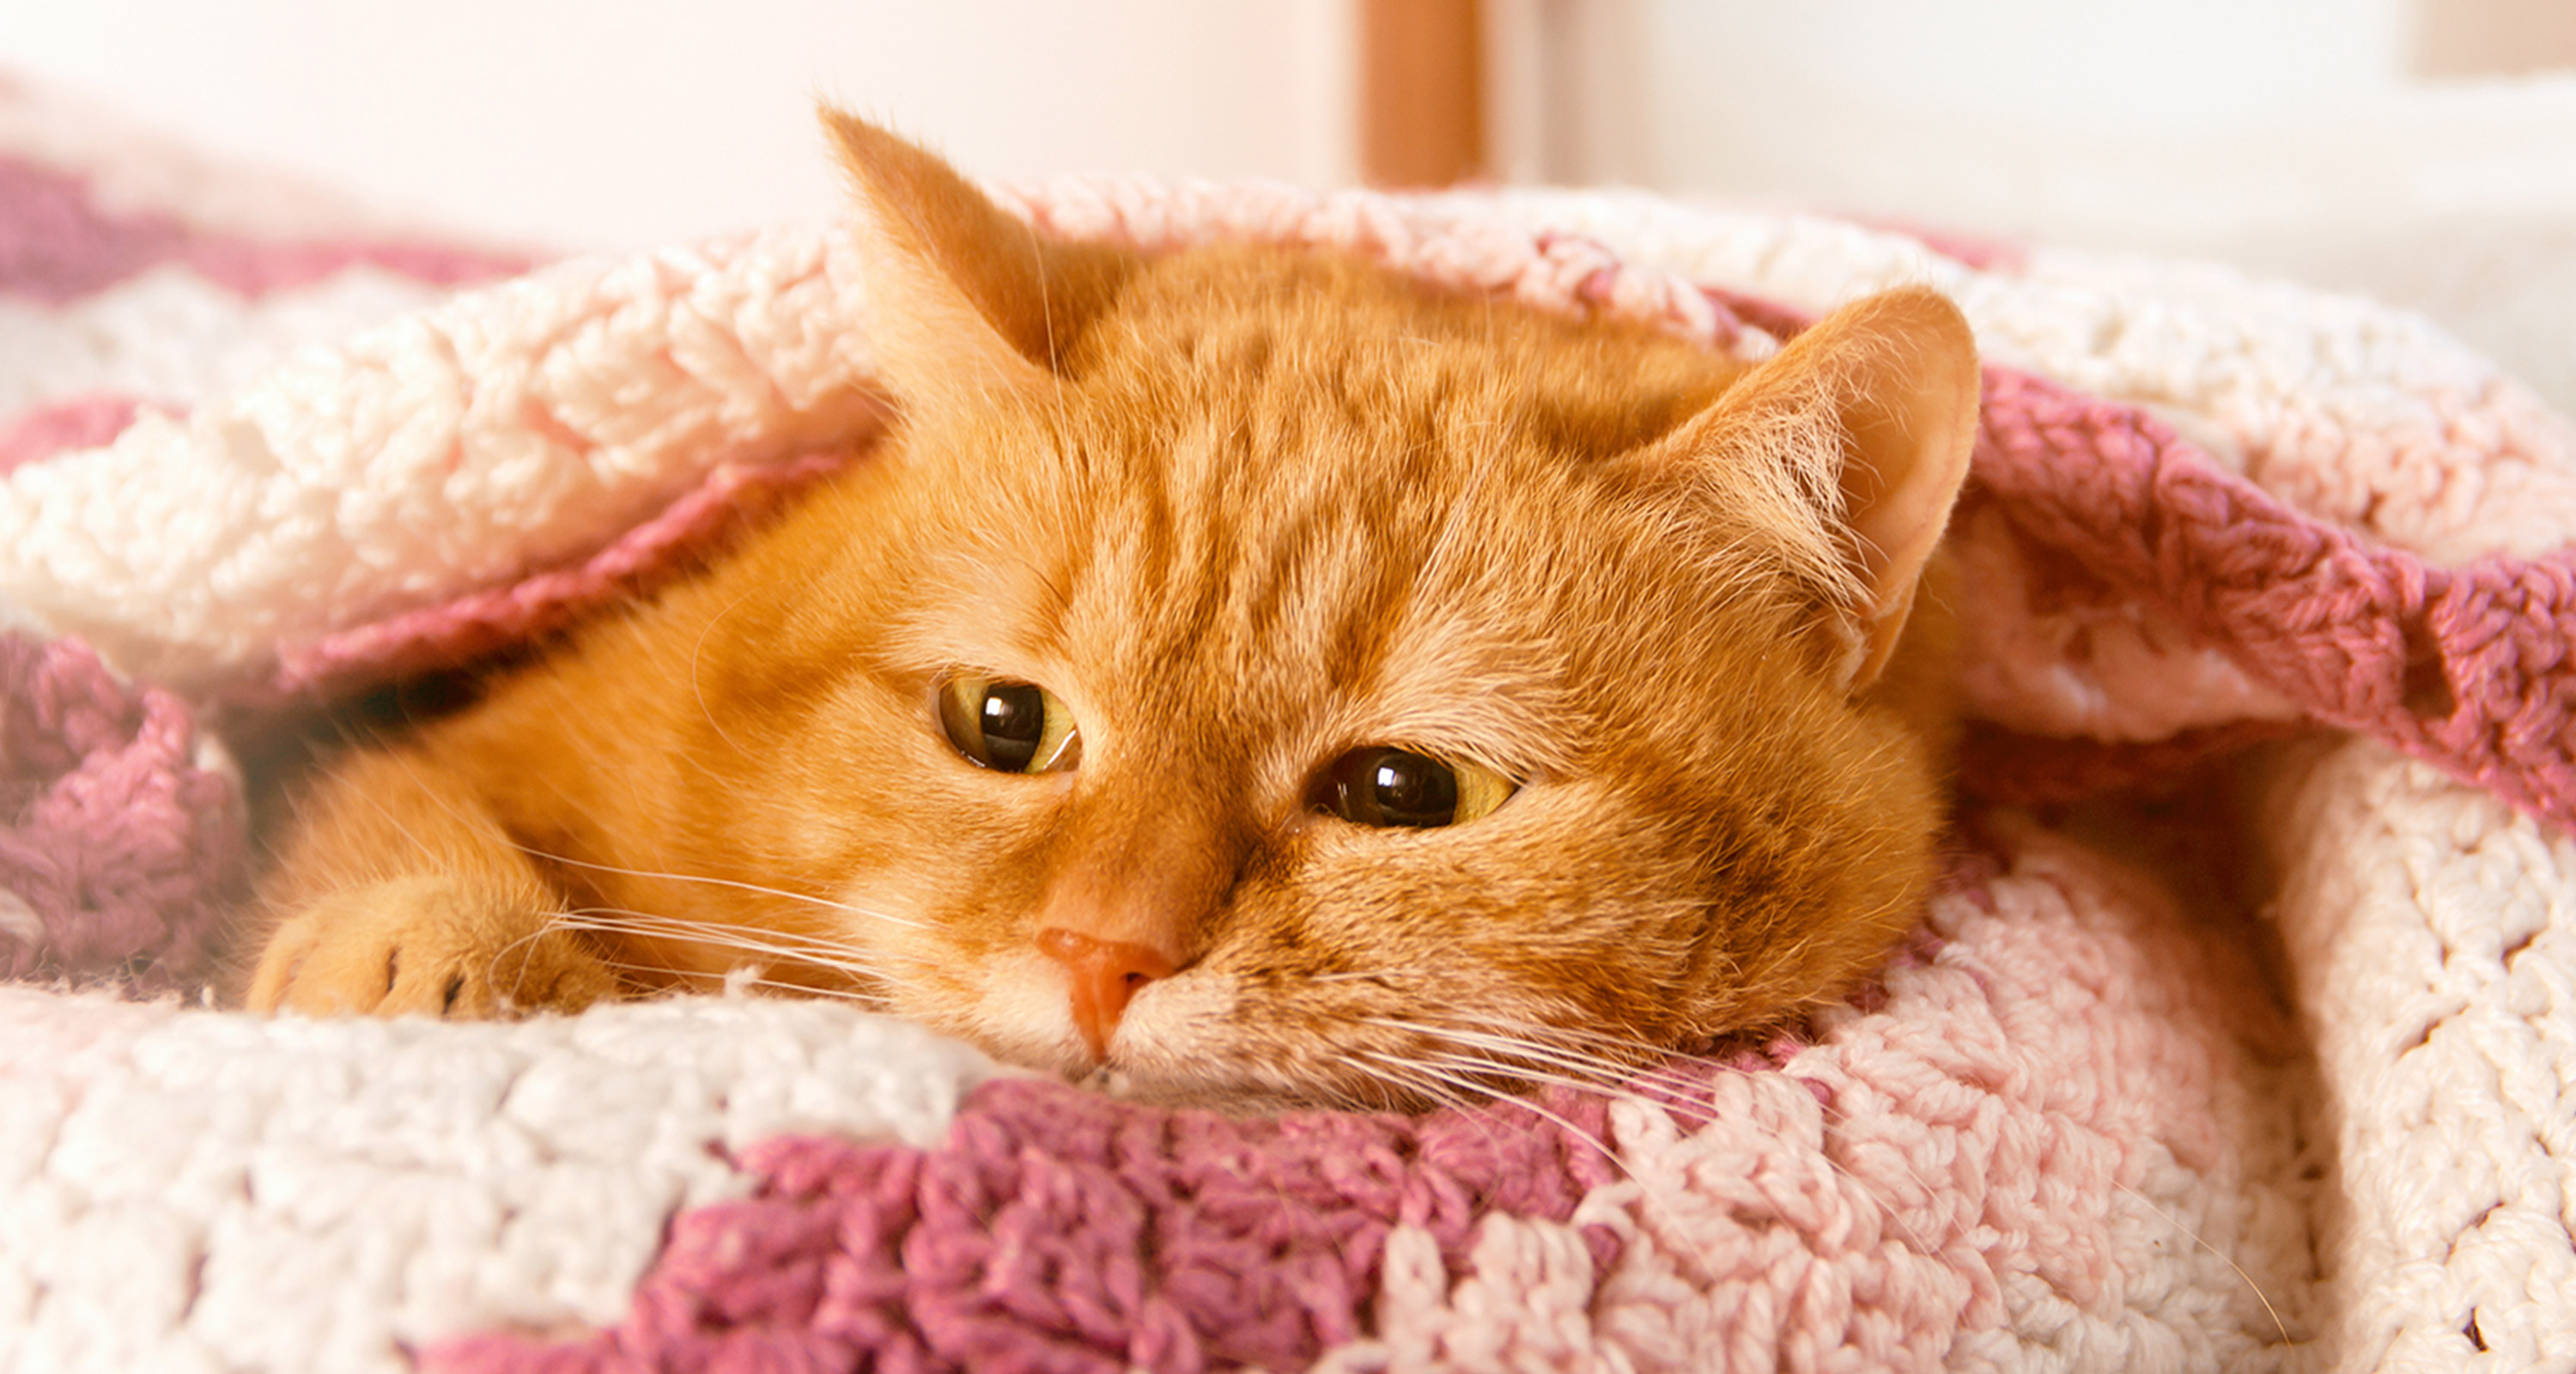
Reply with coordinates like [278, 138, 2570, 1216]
[2259, 740, 2576, 1369]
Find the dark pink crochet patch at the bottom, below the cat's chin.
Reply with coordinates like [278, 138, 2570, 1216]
[420, 1080, 1618, 1374]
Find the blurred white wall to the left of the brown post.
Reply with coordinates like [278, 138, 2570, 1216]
[0, 0, 1355, 247]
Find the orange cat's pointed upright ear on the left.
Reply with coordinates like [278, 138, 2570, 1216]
[822, 106, 1133, 404]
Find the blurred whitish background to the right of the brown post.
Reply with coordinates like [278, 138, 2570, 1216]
[1489, 0, 2576, 410]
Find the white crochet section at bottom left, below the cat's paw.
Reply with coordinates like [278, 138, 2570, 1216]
[0, 988, 992, 1374]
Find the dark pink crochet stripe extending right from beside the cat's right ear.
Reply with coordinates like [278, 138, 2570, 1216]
[1976, 368, 2576, 825]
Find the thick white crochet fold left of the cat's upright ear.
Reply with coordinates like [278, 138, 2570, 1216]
[0, 229, 876, 689]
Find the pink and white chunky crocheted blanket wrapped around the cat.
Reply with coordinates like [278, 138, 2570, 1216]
[0, 82, 2576, 1374]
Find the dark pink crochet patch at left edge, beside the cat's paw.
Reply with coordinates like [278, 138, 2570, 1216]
[0, 634, 245, 988]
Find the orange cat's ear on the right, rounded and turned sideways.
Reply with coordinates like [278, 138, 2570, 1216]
[1677, 286, 1981, 691]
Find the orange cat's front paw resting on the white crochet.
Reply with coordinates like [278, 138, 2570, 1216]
[245, 877, 618, 1018]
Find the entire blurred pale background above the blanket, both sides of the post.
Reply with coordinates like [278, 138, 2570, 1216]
[15, 0, 2576, 407]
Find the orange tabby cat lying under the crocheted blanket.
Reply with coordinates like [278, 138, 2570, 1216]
[247, 116, 1978, 1103]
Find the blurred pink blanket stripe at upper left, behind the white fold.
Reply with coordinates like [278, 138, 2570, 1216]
[0, 155, 536, 304]
